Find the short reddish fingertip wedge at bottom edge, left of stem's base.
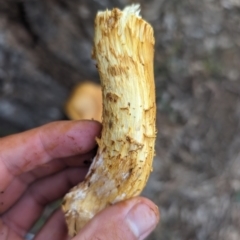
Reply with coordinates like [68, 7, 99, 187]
[34, 209, 69, 240]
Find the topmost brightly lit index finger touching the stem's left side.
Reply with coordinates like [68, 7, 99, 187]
[0, 121, 101, 192]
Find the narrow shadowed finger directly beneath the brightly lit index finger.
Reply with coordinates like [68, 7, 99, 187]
[0, 151, 95, 214]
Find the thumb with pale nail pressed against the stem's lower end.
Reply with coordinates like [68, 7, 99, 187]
[72, 197, 159, 240]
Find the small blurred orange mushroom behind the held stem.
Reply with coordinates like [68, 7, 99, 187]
[65, 81, 102, 122]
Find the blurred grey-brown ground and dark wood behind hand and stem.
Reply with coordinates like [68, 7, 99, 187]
[0, 0, 240, 240]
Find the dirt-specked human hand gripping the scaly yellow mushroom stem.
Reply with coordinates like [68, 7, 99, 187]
[0, 121, 159, 240]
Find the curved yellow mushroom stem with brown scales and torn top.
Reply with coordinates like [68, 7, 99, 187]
[63, 5, 156, 236]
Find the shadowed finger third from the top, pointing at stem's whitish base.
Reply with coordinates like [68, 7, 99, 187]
[2, 168, 86, 236]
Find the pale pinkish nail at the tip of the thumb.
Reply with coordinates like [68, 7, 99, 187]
[126, 203, 158, 239]
